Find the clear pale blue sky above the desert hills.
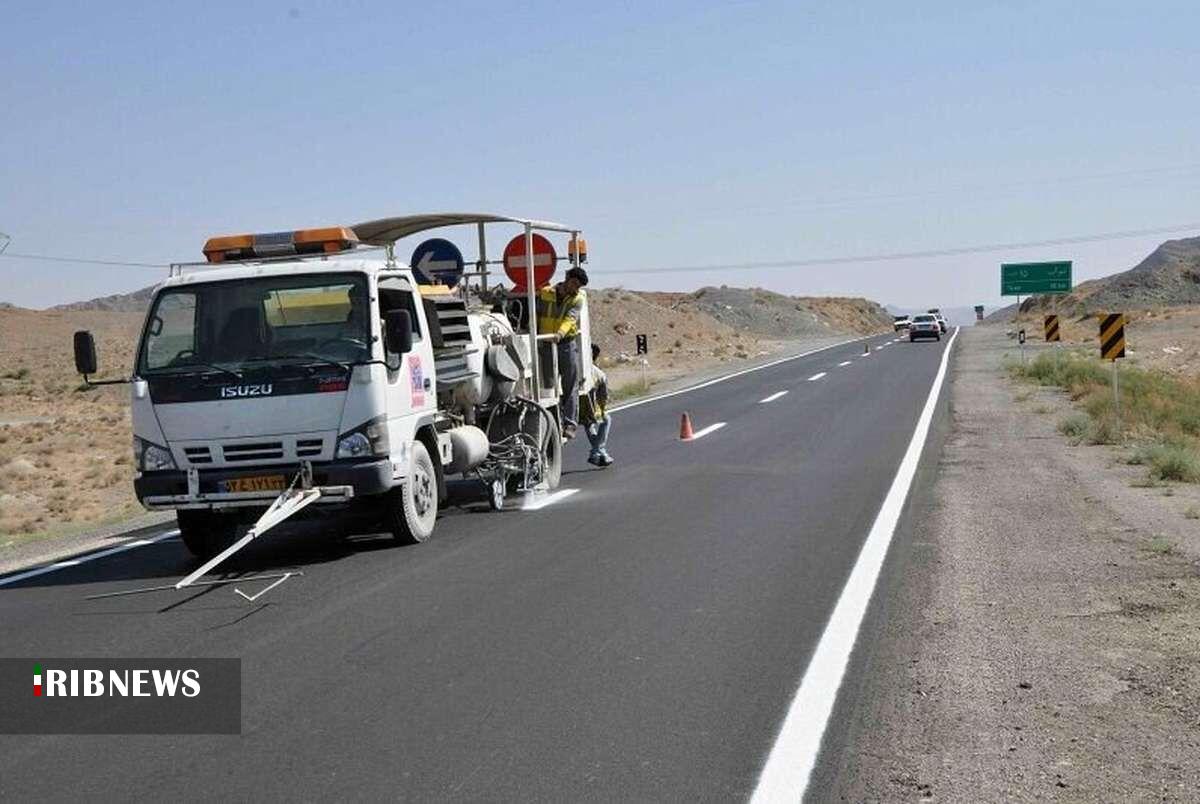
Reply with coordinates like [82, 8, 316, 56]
[0, 0, 1200, 307]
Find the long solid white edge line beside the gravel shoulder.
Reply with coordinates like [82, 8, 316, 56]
[750, 328, 959, 803]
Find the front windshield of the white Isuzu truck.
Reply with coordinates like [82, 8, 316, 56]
[138, 274, 371, 374]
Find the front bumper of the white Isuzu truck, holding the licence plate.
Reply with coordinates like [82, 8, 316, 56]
[133, 458, 395, 510]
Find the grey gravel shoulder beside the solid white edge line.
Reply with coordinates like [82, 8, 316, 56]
[836, 328, 1200, 802]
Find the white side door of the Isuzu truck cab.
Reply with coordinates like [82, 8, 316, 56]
[379, 276, 438, 454]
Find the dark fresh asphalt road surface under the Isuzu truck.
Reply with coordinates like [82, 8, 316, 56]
[0, 337, 947, 800]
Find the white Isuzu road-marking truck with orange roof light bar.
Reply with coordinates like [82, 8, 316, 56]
[74, 214, 592, 569]
